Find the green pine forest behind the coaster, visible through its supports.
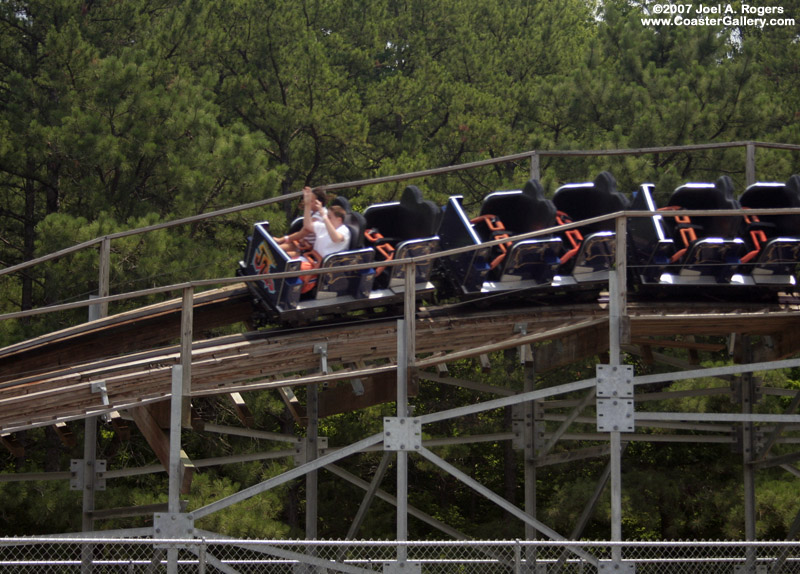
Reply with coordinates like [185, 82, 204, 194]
[0, 0, 800, 539]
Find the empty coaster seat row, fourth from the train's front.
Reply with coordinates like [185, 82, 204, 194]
[553, 171, 629, 286]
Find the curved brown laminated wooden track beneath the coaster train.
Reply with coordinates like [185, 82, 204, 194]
[0, 288, 800, 433]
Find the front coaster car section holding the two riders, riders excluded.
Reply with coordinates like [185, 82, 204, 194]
[238, 207, 381, 321]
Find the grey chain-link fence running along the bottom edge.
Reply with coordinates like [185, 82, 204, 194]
[0, 538, 800, 574]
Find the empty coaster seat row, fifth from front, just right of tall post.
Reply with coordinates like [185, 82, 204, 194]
[629, 176, 745, 286]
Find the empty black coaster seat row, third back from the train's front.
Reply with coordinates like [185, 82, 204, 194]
[439, 180, 562, 294]
